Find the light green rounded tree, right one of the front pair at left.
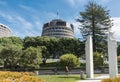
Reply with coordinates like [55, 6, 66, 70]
[20, 47, 42, 68]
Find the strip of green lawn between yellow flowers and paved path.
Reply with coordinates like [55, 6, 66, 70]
[38, 75, 80, 82]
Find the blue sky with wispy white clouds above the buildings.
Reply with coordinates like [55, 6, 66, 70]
[0, 0, 120, 41]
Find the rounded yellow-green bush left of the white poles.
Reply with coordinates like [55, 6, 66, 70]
[60, 54, 80, 67]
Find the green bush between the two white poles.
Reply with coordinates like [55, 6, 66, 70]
[93, 52, 104, 67]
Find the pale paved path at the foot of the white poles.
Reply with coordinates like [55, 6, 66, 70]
[77, 74, 109, 82]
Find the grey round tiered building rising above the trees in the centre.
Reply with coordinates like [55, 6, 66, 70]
[42, 19, 74, 38]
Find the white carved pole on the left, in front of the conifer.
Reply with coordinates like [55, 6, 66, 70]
[85, 35, 94, 78]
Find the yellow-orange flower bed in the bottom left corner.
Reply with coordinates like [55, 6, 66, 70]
[0, 71, 45, 82]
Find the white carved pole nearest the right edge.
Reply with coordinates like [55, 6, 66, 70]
[108, 32, 118, 77]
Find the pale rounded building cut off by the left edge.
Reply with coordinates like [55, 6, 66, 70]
[0, 24, 12, 37]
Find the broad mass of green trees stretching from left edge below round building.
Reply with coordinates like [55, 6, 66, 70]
[0, 36, 85, 68]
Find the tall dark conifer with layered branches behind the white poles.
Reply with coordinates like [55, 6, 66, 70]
[77, 1, 112, 51]
